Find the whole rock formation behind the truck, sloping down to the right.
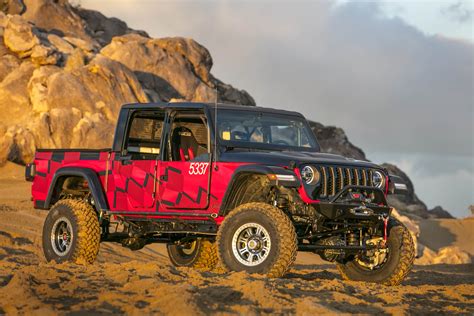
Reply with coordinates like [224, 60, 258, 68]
[0, 0, 447, 217]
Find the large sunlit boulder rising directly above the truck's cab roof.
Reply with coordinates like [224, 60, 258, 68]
[100, 34, 255, 105]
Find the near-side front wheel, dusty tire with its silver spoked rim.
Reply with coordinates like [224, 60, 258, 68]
[217, 203, 297, 277]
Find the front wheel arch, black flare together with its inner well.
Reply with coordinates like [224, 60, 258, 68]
[219, 164, 300, 216]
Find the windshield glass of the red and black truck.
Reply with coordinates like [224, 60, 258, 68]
[217, 109, 319, 151]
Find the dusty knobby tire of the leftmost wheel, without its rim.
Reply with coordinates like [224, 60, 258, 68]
[42, 199, 100, 264]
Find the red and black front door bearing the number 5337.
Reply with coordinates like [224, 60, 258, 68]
[158, 111, 211, 212]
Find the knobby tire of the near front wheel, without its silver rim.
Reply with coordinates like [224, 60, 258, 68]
[217, 202, 298, 278]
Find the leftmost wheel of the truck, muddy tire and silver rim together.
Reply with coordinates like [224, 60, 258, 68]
[43, 199, 100, 263]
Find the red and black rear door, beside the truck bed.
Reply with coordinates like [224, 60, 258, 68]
[112, 110, 165, 211]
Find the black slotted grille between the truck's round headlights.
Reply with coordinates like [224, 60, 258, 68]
[318, 166, 373, 198]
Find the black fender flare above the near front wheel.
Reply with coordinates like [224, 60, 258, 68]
[219, 164, 301, 215]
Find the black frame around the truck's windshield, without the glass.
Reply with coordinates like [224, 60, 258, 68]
[209, 106, 321, 152]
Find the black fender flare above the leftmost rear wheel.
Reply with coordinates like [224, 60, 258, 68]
[44, 167, 108, 211]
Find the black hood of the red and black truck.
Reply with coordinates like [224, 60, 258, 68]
[219, 149, 382, 169]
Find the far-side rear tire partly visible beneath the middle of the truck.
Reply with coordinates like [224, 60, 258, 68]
[166, 238, 219, 271]
